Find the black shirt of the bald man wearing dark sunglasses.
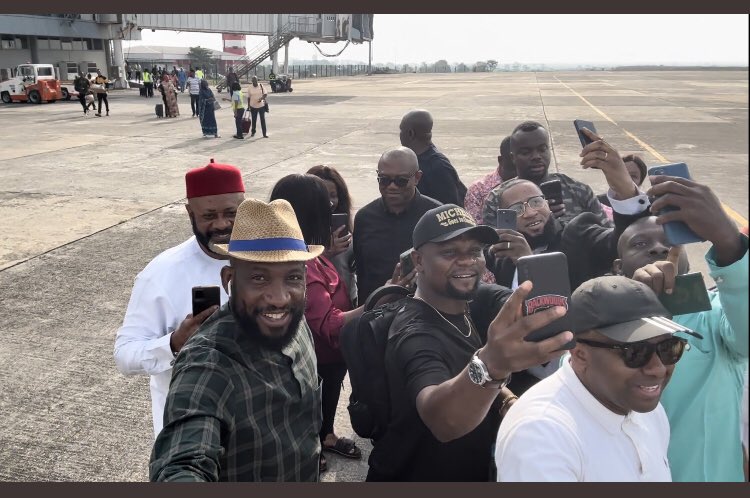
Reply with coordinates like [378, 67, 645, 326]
[353, 191, 440, 303]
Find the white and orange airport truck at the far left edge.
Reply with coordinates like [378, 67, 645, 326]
[0, 64, 73, 104]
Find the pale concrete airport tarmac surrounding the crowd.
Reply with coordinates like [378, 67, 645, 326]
[0, 71, 748, 481]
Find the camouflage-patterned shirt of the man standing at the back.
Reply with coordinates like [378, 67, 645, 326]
[482, 173, 612, 226]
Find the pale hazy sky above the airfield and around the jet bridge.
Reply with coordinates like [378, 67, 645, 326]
[125, 14, 748, 65]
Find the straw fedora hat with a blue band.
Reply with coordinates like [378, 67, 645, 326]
[213, 199, 325, 263]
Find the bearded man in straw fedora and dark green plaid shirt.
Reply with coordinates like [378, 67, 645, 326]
[150, 199, 324, 481]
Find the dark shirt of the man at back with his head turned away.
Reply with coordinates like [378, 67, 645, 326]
[417, 144, 466, 206]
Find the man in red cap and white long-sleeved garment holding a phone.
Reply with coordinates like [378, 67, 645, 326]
[115, 159, 245, 436]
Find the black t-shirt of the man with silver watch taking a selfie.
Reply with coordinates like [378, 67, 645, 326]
[369, 285, 511, 481]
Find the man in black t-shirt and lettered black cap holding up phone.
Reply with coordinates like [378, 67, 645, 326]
[367, 204, 573, 481]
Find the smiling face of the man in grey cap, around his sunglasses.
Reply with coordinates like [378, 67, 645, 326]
[571, 331, 675, 415]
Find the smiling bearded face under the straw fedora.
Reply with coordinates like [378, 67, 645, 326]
[221, 259, 305, 349]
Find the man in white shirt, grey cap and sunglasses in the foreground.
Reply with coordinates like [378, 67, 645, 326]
[495, 276, 696, 481]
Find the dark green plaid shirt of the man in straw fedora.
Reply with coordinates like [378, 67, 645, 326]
[150, 304, 322, 481]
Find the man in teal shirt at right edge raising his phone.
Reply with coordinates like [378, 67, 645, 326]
[615, 177, 748, 481]
